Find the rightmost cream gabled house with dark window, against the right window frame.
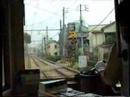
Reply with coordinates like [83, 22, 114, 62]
[98, 21, 116, 60]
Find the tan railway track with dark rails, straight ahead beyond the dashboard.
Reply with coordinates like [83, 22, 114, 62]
[30, 56, 78, 79]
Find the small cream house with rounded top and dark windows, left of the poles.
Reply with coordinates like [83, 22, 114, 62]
[47, 40, 60, 56]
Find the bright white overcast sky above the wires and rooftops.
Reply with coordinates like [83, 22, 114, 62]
[24, 0, 115, 45]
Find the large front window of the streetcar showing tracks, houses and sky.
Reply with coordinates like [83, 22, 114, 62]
[24, 0, 116, 79]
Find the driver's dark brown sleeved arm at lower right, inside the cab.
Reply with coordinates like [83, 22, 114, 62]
[101, 45, 122, 85]
